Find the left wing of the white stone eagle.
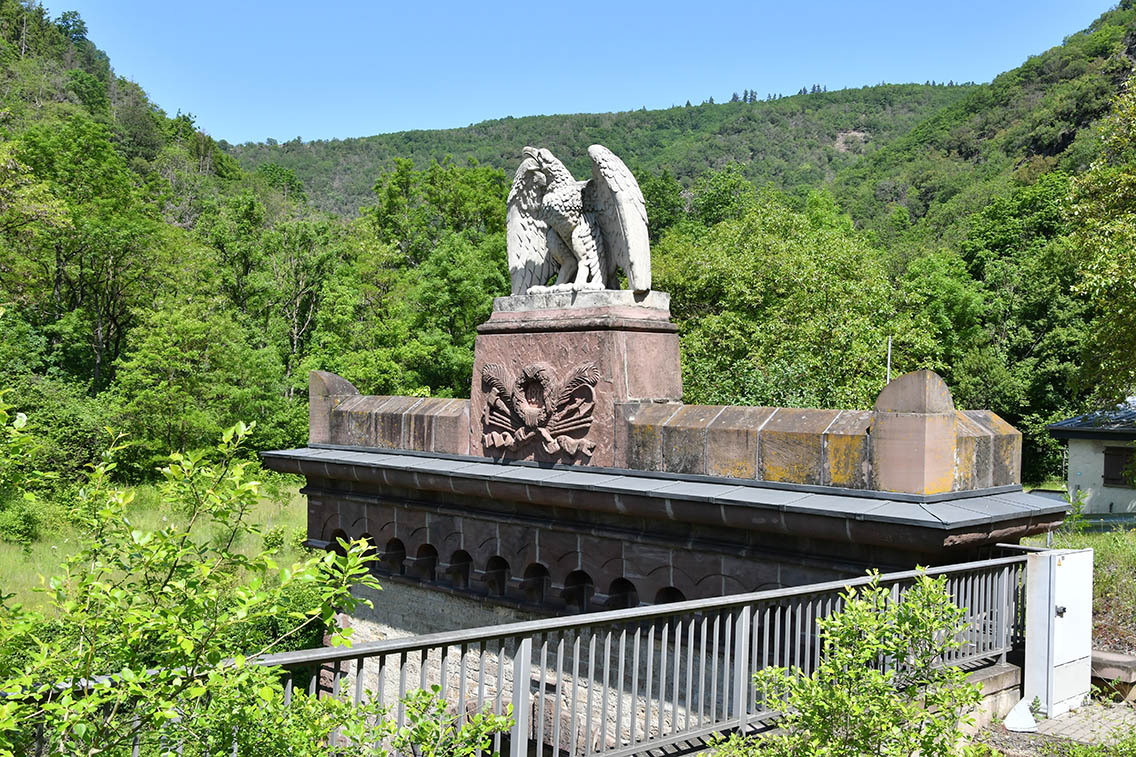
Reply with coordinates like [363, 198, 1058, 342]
[506, 157, 553, 294]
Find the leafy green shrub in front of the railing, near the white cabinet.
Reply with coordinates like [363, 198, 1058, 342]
[715, 574, 979, 757]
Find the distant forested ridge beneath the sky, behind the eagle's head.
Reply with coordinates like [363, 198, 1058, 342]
[225, 83, 971, 215]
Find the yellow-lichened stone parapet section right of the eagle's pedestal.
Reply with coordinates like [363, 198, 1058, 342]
[617, 405, 1021, 494]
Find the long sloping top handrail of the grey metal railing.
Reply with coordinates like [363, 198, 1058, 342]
[257, 555, 1027, 667]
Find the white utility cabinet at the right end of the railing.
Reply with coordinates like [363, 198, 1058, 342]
[1025, 549, 1093, 717]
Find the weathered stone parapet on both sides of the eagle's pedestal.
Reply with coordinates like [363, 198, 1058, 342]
[310, 371, 1021, 496]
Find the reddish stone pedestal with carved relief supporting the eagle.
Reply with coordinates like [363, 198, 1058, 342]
[469, 290, 683, 466]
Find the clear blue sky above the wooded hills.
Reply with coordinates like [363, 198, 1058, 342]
[59, 0, 1112, 142]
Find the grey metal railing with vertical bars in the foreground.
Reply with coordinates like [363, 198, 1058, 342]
[244, 555, 1026, 757]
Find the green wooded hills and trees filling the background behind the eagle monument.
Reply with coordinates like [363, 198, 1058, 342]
[0, 0, 1136, 559]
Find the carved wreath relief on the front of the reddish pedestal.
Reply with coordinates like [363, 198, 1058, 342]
[482, 363, 600, 457]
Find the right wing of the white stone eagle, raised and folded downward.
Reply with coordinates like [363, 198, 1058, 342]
[584, 144, 651, 292]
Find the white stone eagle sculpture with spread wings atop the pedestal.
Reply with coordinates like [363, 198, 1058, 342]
[506, 144, 651, 294]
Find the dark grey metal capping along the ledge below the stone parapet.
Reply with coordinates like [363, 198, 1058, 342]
[261, 446, 1069, 530]
